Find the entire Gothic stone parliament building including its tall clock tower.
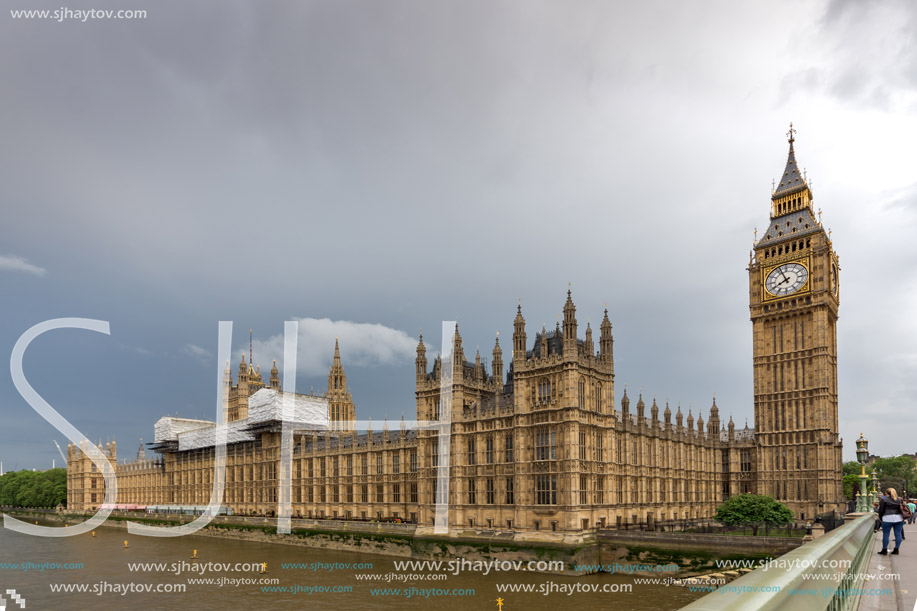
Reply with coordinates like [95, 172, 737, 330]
[67, 131, 844, 540]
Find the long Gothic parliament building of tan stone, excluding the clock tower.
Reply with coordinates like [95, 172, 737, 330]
[68, 292, 756, 538]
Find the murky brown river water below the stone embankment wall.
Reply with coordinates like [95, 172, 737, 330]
[0, 524, 701, 611]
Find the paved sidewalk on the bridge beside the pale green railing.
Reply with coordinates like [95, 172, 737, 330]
[859, 524, 917, 611]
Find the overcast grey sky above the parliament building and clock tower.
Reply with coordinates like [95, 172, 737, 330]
[0, 0, 917, 470]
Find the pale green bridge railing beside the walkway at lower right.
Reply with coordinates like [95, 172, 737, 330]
[683, 513, 875, 611]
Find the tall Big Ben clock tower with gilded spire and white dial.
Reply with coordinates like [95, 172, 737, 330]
[748, 123, 844, 520]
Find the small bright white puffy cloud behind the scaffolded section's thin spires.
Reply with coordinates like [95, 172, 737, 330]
[243, 318, 416, 376]
